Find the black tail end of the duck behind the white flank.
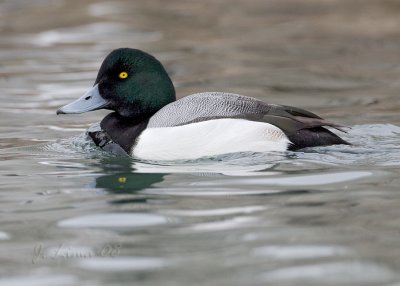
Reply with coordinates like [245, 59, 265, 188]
[288, 127, 351, 151]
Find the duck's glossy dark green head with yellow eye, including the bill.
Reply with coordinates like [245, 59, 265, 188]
[57, 48, 175, 117]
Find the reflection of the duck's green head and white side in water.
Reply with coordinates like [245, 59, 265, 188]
[96, 154, 282, 193]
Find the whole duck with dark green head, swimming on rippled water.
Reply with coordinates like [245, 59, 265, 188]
[56, 48, 351, 160]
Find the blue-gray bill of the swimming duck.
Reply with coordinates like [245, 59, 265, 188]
[57, 84, 109, 114]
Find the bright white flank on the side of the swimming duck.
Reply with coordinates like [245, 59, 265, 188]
[132, 119, 290, 160]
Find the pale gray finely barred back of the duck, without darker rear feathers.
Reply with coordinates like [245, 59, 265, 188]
[147, 92, 271, 128]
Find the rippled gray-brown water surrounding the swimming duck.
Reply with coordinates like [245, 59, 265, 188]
[0, 0, 400, 286]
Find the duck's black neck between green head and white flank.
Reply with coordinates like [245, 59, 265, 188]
[100, 112, 151, 154]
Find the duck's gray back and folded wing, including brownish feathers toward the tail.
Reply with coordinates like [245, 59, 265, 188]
[148, 92, 343, 136]
